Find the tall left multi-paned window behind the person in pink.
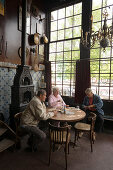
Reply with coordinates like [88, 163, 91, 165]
[49, 2, 82, 96]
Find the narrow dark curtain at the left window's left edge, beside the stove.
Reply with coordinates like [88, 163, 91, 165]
[45, 61, 51, 100]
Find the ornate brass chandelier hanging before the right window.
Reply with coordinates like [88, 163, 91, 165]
[81, 3, 113, 51]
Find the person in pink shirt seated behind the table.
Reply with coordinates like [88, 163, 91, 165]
[48, 87, 66, 109]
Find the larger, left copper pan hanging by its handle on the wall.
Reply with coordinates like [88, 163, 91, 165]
[28, 23, 40, 45]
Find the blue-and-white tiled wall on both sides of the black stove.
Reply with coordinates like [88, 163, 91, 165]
[0, 62, 42, 122]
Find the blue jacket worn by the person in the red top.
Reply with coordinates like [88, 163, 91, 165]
[82, 94, 104, 115]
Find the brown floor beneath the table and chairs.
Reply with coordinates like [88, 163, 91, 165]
[0, 127, 113, 170]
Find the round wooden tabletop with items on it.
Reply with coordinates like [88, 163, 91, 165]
[50, 107, 86, 122]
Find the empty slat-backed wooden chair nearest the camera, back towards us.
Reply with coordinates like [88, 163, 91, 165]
[49, 123, 70, 170]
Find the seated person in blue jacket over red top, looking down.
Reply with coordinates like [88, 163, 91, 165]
[82, 88, 104, 132]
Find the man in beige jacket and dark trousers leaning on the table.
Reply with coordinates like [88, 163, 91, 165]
[21, 90, 56, 150]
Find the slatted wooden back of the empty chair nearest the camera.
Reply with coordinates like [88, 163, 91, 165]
[49, 123, 70, 144]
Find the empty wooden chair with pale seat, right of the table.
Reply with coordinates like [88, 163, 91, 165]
[74, 112, 96, 152]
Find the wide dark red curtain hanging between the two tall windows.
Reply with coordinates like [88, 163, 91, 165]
[75, 59, 91, 104]
